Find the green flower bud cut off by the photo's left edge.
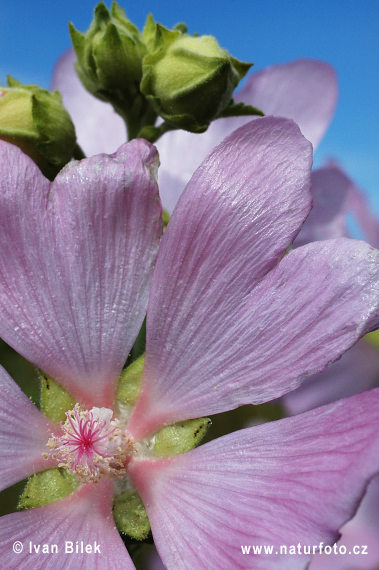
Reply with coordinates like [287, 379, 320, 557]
[0, 78, 76, 180]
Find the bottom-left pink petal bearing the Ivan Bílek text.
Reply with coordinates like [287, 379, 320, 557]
[0, 481, 134, 570]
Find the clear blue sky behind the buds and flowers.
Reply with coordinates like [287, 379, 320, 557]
[0, 0, 379, 215]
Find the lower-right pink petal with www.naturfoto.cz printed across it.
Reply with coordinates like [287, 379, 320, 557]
[130, 390, 379, 570]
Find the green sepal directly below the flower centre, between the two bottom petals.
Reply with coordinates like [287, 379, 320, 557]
[113, 491, 150, 540]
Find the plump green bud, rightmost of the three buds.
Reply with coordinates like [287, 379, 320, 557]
[140, 24, 252, 133]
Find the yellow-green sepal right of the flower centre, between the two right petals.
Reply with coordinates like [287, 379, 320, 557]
[154, 418, 212, 457]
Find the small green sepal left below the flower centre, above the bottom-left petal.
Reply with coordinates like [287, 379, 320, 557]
[17, 468, 80, 509]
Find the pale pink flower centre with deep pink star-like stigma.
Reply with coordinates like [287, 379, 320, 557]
[44, 404, 135, 483]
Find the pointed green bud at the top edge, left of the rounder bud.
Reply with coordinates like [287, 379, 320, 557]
[70, 2, 146, 106]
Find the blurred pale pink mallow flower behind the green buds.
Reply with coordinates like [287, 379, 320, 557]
[52, 50, 337, 213]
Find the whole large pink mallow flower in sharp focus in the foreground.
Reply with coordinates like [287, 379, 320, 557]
[0, 117, 379, 570]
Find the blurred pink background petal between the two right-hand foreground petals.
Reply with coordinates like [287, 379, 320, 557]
[283, 339, 379, 414]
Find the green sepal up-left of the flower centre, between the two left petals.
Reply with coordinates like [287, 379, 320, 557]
[40, 372, 76, 423]
